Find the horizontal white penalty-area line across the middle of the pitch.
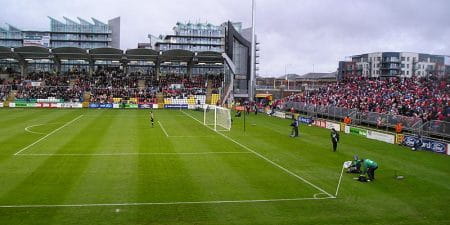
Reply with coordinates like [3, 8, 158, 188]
[14, 152, 250, 156]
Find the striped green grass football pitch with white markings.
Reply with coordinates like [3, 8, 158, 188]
[0, 109, 450, 225]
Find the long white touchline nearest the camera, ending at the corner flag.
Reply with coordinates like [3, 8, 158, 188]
[0, 197, 334, 208]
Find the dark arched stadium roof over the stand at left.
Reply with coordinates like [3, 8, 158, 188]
[0, 46, 223, 63]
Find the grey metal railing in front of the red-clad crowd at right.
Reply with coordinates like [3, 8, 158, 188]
[284, 101, 450, 139]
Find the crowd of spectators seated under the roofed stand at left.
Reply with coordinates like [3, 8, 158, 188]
[1, 70, 221, 103]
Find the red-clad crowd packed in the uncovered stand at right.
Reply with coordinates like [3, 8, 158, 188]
[284, 77, 450, 121]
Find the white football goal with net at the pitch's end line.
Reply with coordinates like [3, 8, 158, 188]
[203, 105, 231, 131]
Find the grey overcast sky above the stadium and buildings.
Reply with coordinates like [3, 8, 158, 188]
[0, 0, 450, 76]
